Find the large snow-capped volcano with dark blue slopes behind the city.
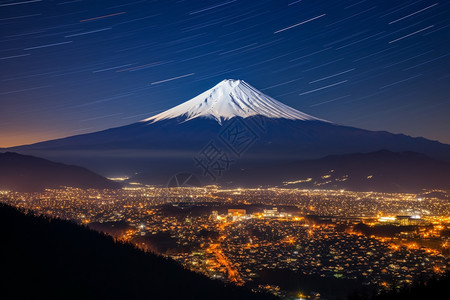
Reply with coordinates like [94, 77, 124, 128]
[8, 79, 450, 189]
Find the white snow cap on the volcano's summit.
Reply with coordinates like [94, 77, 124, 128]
[142, 79, 323, 123]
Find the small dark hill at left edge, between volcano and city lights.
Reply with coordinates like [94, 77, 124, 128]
[0, 152, 119, 192]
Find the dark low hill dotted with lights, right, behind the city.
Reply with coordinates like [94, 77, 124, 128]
[228, 150, 450, 193]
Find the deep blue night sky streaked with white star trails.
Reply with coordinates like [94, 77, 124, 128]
[0, 0, 450, 147]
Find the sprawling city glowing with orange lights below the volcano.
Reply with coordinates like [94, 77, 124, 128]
[0, 186, 450, 297]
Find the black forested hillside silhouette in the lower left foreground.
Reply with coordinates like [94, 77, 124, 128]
[0, 204, 276, 300]
